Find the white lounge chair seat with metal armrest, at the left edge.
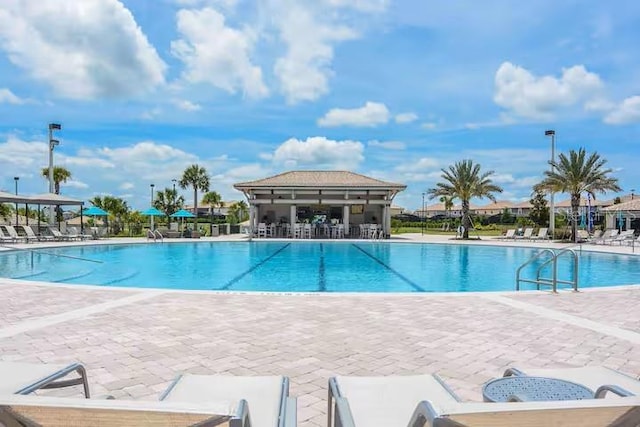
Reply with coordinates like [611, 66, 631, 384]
[0, 362, 89, 400]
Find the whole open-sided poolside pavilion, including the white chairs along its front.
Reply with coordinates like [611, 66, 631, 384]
[234, 171, 406, 238]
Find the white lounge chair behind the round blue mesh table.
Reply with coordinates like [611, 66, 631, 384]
[504, 366, 640, 398]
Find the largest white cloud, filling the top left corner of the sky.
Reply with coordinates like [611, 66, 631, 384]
[0, 0, 166, 99]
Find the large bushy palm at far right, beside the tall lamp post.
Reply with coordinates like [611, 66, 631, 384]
[533, 148, 622, 242]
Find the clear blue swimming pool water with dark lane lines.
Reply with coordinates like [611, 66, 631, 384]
[0, 242, 640, 292]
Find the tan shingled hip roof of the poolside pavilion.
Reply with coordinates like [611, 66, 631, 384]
[234, 171, 407, 190]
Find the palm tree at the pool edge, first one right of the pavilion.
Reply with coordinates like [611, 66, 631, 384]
[427, 160, 502, 239]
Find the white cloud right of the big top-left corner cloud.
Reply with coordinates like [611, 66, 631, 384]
[171, 8, 269, 98]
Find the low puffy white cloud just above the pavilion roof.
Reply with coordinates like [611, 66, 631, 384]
[272, 136, 364, 169]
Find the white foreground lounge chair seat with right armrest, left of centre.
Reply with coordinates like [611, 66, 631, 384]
[160, 374, 296, 427]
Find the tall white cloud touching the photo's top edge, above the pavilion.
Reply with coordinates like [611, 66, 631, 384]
[271, 0, 357, 104]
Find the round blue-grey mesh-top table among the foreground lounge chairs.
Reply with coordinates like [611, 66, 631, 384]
[482, 376, 593, 402]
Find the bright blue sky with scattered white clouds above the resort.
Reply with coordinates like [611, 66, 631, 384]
[0, 0, 640, 209]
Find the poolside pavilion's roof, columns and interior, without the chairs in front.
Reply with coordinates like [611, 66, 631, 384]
[234, 171, 407, 238]
